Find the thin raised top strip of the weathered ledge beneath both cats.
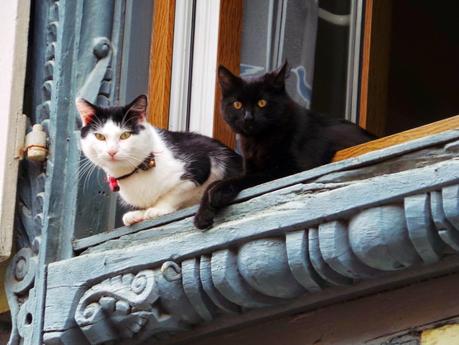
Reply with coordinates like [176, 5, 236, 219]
[73, 130, 459, 251]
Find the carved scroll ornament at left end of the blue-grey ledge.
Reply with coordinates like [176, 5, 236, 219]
[75, 270, 186, 344]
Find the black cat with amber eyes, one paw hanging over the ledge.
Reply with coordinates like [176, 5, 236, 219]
[194, 62, 375, 229]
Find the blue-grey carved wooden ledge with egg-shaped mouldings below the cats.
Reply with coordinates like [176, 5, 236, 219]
[44, 133, 459, 344]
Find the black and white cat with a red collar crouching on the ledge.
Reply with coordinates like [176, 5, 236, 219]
[76, 95, 242, 225]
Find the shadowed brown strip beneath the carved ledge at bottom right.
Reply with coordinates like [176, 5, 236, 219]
[177, 274, 459, 345]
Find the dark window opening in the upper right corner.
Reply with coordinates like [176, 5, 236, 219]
[385, 0, 459, 135]
